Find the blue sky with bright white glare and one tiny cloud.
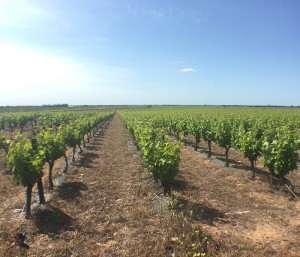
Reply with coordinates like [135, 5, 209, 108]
[0, 0, 300, 106]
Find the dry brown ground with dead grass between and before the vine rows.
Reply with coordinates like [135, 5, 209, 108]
[0, 116, 300, 257]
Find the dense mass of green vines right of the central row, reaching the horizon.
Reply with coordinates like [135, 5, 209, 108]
[120, 108, 300, 183]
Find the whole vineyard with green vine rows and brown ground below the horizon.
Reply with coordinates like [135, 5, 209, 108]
[0, 107, 300, 256]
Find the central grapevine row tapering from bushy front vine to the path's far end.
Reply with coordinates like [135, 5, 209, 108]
[121, 112, 180, 189]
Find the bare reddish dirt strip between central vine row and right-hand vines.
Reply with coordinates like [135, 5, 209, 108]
[176, 147, 300, 256]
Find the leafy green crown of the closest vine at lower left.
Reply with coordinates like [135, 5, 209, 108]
[8, 136, 44, 187]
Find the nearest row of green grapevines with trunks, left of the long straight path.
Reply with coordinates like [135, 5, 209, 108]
[1, 109, 113, 217]
